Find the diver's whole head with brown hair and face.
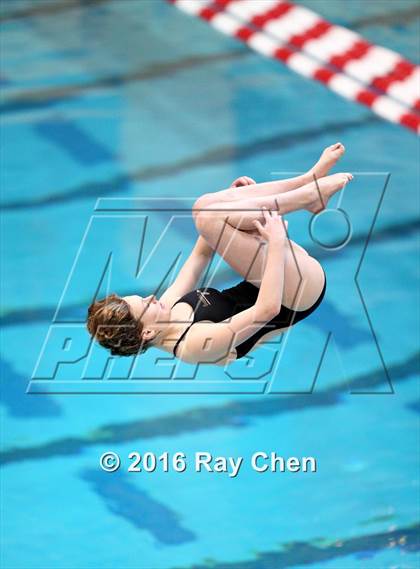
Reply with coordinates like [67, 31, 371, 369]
[87, 294, 170, 356]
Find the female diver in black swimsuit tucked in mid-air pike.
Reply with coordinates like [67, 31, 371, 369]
[87, 143, 353, 365]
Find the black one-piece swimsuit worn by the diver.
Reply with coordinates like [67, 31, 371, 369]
[173, 272, 327, 359]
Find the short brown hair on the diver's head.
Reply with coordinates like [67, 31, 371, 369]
[86, 294, 147, 356]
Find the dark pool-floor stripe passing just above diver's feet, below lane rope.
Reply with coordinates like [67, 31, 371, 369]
[0, 115, 381, 211]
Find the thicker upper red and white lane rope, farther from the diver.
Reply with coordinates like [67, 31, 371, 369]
[217, 0, 420, 111]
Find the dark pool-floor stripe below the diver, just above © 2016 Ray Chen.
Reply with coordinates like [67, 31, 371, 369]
[0, 352, 420, 465]
